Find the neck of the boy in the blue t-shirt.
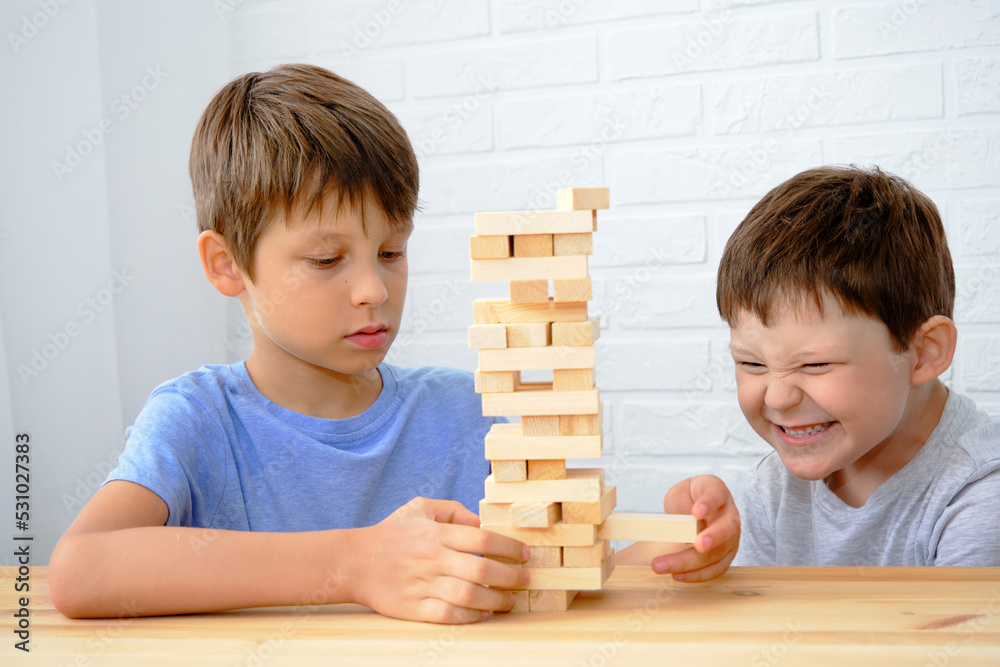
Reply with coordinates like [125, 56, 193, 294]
[246, 348, 382, 419]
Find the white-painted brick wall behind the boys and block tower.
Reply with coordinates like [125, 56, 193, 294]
[229, 0, 1000, 511]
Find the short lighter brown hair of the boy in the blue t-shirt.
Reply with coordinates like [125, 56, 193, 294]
[189, 65, 420, 280]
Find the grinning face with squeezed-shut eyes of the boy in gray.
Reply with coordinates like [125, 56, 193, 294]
[730, 297, 912, 480]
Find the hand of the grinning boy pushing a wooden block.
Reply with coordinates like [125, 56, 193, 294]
[652, 475, 740, 582]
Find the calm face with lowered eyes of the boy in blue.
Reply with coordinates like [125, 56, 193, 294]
[241, 198, 412, 375]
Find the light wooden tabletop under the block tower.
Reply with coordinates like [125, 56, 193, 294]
[0, 567, 1000, 667]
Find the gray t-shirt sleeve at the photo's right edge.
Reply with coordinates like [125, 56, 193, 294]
[934, 467, 1000, 567]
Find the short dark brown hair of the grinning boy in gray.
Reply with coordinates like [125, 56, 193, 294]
[716, 165, 955, 350]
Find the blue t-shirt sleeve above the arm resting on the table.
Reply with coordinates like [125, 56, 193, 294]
[104, 386, 226, 526]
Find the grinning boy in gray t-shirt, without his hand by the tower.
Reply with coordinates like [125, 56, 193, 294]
[716, 167, 1000, 566]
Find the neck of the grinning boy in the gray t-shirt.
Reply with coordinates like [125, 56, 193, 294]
[825, 380, 948, 507]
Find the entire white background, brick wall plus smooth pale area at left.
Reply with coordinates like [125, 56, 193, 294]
[0, 0, 1000, 565]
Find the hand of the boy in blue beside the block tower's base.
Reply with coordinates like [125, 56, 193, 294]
[352, 498, 529, 623]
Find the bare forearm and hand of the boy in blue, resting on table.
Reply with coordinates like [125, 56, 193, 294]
[49, 481, 526, 623]
